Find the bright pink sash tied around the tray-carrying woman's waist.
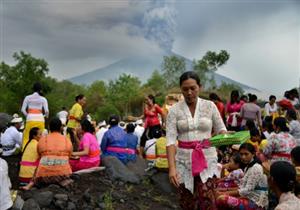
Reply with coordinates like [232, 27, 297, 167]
[178, 139, 211, 176]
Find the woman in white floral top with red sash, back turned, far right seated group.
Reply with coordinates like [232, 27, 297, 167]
[262, 117, 296, 163]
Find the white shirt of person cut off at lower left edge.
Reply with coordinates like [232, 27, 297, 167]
[0, 158, 13, 210]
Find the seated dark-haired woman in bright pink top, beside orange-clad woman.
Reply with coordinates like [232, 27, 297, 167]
[70, 119, 100, 172]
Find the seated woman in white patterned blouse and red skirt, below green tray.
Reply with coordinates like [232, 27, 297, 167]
[216, 143, 268, 210]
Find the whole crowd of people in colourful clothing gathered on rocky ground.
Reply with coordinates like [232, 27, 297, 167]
[0, 71, 300, 210]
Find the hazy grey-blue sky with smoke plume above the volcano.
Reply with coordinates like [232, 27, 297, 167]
[0, 0, 300, 95]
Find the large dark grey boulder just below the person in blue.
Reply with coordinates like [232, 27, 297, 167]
[102, 156, 141, 184]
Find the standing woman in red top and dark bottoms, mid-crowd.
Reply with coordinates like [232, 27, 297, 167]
[140, 95, 165, 155]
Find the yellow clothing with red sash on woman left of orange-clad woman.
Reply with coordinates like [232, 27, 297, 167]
[19, 139, 39, 178]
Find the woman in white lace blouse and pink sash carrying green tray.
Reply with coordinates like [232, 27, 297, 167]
[166, 71, 226, 210]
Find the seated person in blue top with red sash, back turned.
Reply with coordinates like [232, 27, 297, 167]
[101, 115, 128, 164]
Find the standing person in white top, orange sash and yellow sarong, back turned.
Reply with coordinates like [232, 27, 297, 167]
[21, 82, 49, 151]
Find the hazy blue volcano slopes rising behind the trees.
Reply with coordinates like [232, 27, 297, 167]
[69, 50, 260, 92]
